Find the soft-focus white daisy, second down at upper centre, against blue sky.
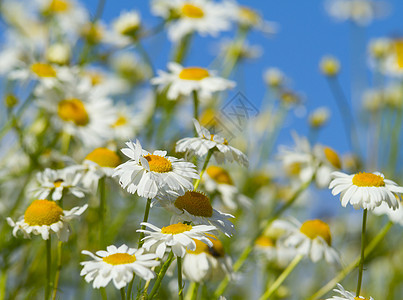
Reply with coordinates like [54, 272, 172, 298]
[151, 62, 235, 100]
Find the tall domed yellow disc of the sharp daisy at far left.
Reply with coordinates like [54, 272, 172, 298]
[24, 200, 63, 226]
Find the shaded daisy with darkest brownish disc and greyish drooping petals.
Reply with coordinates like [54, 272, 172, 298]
[154, 191, 235, 236]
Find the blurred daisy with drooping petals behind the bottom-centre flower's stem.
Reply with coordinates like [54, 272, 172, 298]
[182, 234, 232, 282]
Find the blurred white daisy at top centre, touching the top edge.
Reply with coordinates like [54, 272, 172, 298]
[151, 0, 231, 42]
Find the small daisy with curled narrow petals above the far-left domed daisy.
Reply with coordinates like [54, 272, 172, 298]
[34, 168, 85, 200]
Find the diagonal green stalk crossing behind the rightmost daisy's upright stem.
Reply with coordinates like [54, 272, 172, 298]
[308, 221, 393, 300]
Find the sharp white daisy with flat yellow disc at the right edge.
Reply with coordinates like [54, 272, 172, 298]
[329, 172, 403, 210]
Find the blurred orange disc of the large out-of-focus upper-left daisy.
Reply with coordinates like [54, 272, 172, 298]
[57, 98, 90, 126]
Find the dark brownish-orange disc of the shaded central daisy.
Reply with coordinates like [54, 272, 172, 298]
[174, 191, 213, 218]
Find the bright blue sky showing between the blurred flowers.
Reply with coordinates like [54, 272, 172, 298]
[84, 0, 403, 152]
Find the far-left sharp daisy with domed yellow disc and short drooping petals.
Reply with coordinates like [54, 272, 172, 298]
[7, 200, 88, 242]
